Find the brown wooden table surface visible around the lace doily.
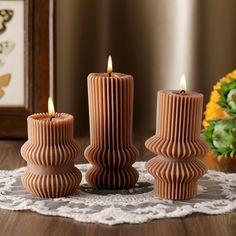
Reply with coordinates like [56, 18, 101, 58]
[0, 134, 236, 236]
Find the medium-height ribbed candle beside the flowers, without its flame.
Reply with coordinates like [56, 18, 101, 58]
[145, 91, 208, 200]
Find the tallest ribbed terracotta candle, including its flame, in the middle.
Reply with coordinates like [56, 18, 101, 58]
[84, 55, 138, 189]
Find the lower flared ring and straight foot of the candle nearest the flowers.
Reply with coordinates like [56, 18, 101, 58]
[146, 156, 207, 200]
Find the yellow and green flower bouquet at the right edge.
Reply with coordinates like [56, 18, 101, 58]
[203, 70, 236, 172]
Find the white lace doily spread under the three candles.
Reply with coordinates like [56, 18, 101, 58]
[0, 162, 236, 225]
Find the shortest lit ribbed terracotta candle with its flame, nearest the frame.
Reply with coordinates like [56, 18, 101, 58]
[21, 99, 81, 198]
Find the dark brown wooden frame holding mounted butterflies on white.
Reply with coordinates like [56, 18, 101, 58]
[0, 0, 55, 138]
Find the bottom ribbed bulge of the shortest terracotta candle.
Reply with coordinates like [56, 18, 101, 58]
[21, 167, 82, 198]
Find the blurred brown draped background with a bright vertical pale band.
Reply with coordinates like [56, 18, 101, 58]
[56, 0, 236, 136]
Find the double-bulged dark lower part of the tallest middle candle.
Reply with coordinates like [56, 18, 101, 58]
[84, 145, 139, 190]
